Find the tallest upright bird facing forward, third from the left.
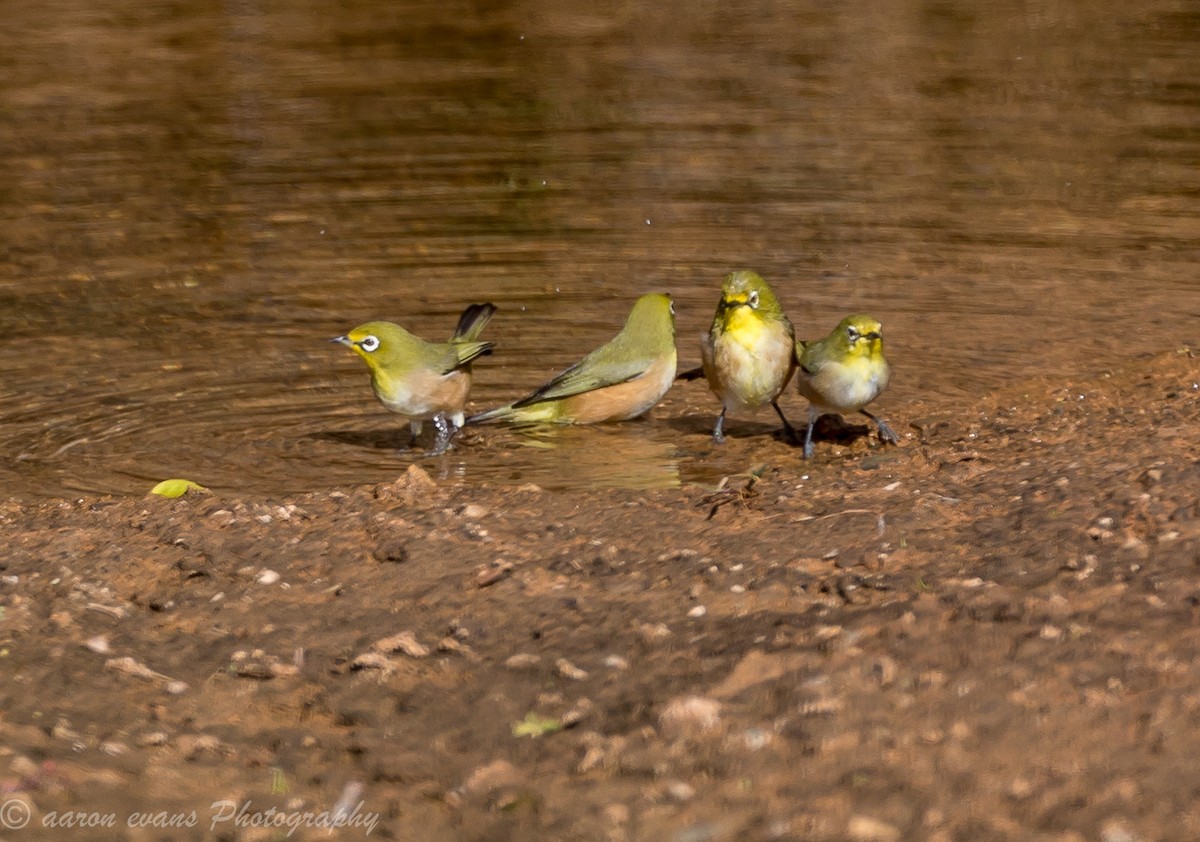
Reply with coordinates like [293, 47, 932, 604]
[680, 270, 796, 444]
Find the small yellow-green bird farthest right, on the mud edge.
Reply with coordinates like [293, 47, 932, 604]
[796, 315, 900, 459]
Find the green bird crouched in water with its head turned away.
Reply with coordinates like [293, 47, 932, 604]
[467, 293, 676, 425]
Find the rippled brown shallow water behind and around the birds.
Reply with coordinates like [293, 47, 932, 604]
[0, 0, 1200, 495]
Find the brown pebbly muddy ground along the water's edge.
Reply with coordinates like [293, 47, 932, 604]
[0, 351, 1200, 842]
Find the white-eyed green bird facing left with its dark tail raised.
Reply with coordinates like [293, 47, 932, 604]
[330, 303, 496, 456]
